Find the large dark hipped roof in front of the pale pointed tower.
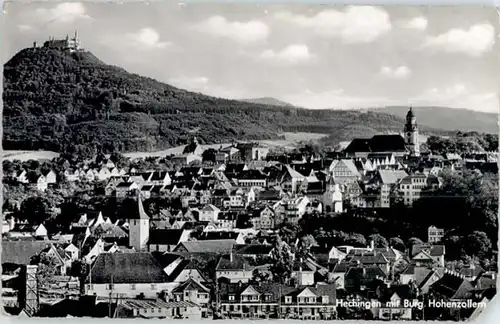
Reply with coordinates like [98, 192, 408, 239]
[87, 252, 167, 284]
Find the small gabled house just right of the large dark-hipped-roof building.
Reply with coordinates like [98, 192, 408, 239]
[172, 278, 210, 318]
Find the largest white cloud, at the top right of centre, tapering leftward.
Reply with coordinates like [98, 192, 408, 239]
[275, 6, 392, 43]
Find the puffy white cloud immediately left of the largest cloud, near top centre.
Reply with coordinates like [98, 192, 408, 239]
[195, 16, 270, 44]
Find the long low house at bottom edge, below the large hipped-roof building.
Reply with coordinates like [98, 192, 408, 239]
[114, 299, 202, 320]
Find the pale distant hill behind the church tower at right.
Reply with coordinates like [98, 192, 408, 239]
[375, 107, 498, 134]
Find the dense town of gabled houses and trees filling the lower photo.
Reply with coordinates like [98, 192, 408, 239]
[2, 108, 498, 320]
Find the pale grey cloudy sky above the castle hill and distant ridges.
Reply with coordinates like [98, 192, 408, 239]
[2, 2, 500, 113]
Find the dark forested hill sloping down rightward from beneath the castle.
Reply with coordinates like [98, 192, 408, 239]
[3, 48, 450, 152]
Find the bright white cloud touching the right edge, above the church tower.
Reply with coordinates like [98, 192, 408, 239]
[422, 23, 495, 57]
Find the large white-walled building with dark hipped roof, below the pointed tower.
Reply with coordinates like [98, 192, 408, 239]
[85, 252, 177, 298]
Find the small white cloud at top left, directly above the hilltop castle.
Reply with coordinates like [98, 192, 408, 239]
[35, 2, 92, 23]
